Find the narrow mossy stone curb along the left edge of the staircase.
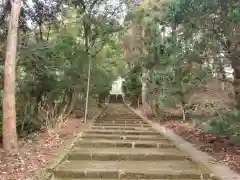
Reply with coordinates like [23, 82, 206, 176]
[36, 105, 107, 180]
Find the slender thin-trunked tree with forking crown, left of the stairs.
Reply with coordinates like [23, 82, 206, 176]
[69, 0, 124, 121]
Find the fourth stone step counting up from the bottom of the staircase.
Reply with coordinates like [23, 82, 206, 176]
[81, 132, 167, 141]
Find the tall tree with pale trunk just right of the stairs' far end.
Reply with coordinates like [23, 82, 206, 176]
[125, 0, 170, 115]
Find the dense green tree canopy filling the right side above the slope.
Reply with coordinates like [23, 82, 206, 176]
[123, 0, 240, 143]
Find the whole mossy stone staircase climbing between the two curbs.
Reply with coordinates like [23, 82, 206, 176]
[50, 104, 214, 180]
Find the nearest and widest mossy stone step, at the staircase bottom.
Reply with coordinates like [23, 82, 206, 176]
[54, 160, 210, 180]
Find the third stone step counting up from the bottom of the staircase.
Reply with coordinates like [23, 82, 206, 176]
[76, 139, 175, 148]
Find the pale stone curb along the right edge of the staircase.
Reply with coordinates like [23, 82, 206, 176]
[125, 103, 240, 180]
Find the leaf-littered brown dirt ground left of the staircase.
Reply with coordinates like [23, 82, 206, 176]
[0, 118, 87, 180]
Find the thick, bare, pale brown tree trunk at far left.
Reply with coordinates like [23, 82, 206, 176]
[3, 0, 21, 153]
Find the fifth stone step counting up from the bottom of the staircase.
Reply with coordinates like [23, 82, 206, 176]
[86, 128, 159, 135]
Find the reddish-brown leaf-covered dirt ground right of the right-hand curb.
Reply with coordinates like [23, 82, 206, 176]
[161, 121, 240, 173]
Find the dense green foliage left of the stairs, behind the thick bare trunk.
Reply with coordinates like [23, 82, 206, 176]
[0, 0, 123, 136]
